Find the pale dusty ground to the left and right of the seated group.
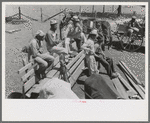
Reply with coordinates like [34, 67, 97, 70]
[5, 18, 145, 98]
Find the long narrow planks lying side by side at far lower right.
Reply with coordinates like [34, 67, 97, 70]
[119, 61, 145, 99]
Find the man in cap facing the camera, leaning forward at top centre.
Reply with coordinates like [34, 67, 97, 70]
[65, 16, 86, 53]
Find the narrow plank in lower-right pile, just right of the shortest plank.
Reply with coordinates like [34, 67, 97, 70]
[125, 73, 145, 99]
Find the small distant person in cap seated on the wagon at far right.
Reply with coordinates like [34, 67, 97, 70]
[128, 16, 142, 40]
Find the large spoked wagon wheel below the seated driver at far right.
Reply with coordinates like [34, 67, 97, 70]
[120, 33, 144, 52]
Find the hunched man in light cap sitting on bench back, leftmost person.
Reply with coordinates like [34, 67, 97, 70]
[29, 30, 54, 78]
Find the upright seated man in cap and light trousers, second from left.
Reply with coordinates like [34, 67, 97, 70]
[45, 20, 68, 55]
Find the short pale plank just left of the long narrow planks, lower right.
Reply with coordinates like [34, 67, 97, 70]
[118, 74, 137, 94]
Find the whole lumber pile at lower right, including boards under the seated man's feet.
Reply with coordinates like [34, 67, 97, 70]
[100, 61, 145, 99]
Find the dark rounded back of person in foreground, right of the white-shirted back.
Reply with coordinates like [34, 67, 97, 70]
[85, 74, 119, 99]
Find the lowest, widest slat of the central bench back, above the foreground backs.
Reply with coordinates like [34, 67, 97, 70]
[69, 61, 84, 87]
